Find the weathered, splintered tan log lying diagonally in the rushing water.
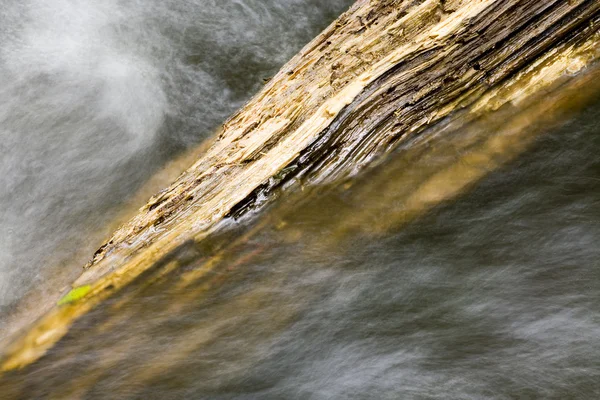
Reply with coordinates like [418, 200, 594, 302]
[1, 0, 600, 371]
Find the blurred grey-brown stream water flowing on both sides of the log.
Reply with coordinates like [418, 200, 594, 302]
[0, 0, 600, 400]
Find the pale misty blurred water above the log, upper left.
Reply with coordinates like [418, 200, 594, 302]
[0, 0, 352, 312]
